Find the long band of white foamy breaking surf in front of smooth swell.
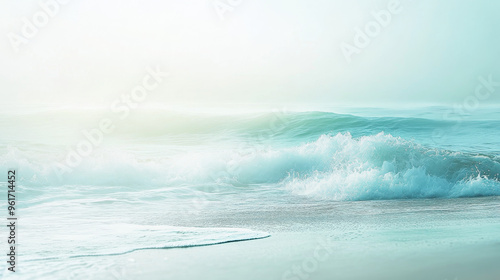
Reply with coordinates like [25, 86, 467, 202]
[4, 133, 500, 200]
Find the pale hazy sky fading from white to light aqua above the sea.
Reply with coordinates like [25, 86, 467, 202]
[0, 0, 500, 106]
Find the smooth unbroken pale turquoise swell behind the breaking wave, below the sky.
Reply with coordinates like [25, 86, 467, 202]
[0, 110, 464, 139]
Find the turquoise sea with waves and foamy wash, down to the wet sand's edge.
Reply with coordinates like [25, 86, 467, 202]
[0, 107, 500, 279]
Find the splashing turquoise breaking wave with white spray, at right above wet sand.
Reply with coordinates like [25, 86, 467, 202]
[282, 133, 500, 200]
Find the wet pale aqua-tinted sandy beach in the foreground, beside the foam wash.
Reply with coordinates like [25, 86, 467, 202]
[17, 197, 500, 280]
